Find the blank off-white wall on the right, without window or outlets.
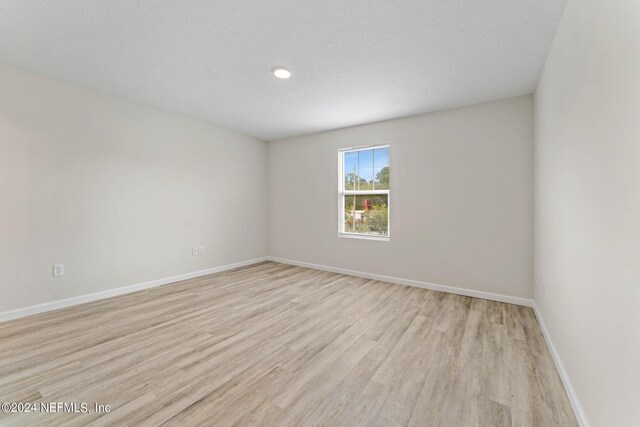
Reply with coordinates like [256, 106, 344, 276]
[535, 0, 640, 427]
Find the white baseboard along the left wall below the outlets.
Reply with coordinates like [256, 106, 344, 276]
[0, 257, 267, 322]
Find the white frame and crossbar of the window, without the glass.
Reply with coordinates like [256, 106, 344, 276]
[338, 144, 391, 242]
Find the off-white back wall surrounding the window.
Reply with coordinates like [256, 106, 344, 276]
[269, 96, 533, 298]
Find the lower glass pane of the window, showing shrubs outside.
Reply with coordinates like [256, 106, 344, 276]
[343, 194, 389, 236]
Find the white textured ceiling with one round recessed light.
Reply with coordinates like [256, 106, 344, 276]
[0, 0, 565, 141]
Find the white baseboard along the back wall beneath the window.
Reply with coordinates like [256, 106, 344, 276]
[267, 256, 533, 307]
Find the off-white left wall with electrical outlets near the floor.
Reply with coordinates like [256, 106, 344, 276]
[0, 65, 268, 311]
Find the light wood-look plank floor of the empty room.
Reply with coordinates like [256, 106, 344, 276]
[0, 262, 576, 427]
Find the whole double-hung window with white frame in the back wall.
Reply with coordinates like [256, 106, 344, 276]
[338, 145, 390, 240]
